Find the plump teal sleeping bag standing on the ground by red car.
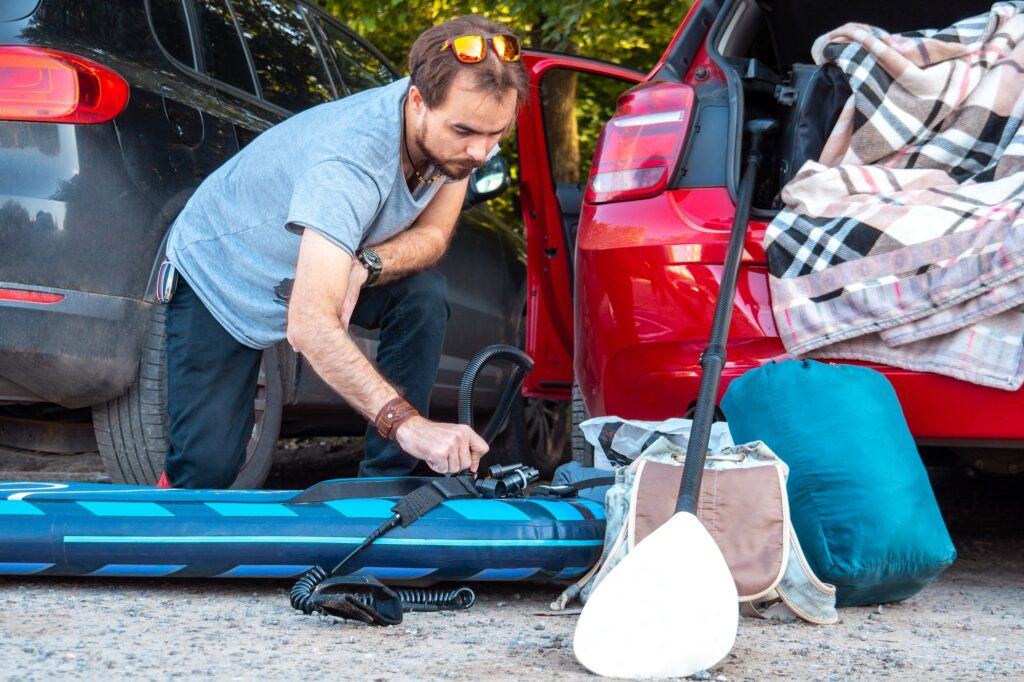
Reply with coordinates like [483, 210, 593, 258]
[722, 360, 956, 606]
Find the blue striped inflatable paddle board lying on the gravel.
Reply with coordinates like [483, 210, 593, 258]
[0, 477, 604, 583]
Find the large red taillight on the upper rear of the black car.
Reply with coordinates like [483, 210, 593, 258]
[0, 45, 128, 123]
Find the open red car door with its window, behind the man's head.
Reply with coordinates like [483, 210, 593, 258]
[517, 50, 645, 399]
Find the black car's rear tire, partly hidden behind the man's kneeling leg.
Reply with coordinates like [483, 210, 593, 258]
[92, 305, 282, 488]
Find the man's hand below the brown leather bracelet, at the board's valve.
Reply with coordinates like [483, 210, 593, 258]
[395, 417, 490, 474]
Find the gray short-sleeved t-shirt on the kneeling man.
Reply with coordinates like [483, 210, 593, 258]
[167, 79, 442, 348]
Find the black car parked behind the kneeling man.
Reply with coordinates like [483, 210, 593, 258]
[0, 0, 543, 487]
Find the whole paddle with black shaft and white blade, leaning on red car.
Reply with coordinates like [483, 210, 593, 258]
[572, 120, 777, 679]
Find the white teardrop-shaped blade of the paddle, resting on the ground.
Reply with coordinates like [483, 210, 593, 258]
[572, 512, 739, 679]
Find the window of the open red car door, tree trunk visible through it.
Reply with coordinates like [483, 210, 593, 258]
[540, 69, 633, 184]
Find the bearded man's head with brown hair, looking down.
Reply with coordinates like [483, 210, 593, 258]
[409, 15, 529, 179]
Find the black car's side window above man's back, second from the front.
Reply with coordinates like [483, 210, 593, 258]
[232, 0, 334, 112]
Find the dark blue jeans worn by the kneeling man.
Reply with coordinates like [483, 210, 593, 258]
[165, 270, 449, 488]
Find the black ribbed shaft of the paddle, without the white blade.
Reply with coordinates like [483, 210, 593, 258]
[676, 120, 777, 515]
